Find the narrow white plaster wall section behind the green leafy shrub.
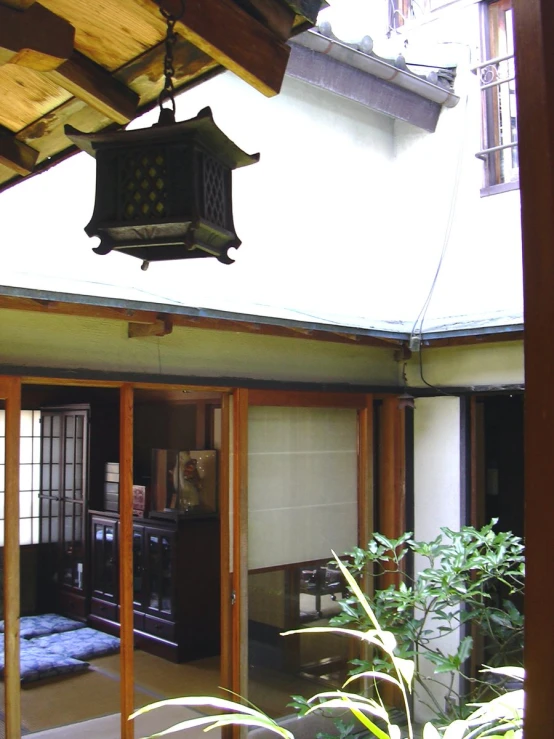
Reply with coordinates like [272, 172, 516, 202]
[414, 397, 462, 721]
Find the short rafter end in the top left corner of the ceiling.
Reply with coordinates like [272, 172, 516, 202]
[0, 3, 75, 72]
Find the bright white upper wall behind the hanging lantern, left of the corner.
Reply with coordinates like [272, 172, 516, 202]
[0, 73, 395, 324]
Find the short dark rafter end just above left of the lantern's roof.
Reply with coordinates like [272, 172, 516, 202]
[48, 51, 139, 125]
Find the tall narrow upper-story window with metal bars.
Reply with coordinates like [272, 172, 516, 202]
[475, 0, 519, 193]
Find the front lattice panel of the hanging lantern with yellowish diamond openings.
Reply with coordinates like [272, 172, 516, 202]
[120, 148, 167, 221]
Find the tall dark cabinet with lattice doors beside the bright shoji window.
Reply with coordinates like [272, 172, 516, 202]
[40, 406, 89, 618]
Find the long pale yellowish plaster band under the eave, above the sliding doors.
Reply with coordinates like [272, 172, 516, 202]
[0, 310, 397, 385]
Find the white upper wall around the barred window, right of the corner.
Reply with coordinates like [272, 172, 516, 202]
[395, 0, 523, 329]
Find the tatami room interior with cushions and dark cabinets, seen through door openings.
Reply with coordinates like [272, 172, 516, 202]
[0, 384, 226, 736]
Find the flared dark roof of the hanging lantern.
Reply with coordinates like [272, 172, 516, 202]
[64, 108, 260, 169]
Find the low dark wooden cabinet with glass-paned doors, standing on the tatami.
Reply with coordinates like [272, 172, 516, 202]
[89, 513, 220, 662]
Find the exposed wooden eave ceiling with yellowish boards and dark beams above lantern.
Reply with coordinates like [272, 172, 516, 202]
[0, 0, 323, 191]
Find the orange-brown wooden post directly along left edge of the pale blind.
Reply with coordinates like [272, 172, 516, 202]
[232, 389, 248, 712]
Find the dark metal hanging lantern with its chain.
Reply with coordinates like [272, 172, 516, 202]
[65, 2, 259, 269]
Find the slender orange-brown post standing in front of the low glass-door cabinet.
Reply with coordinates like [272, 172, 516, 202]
[119, 384, 134, 739]
